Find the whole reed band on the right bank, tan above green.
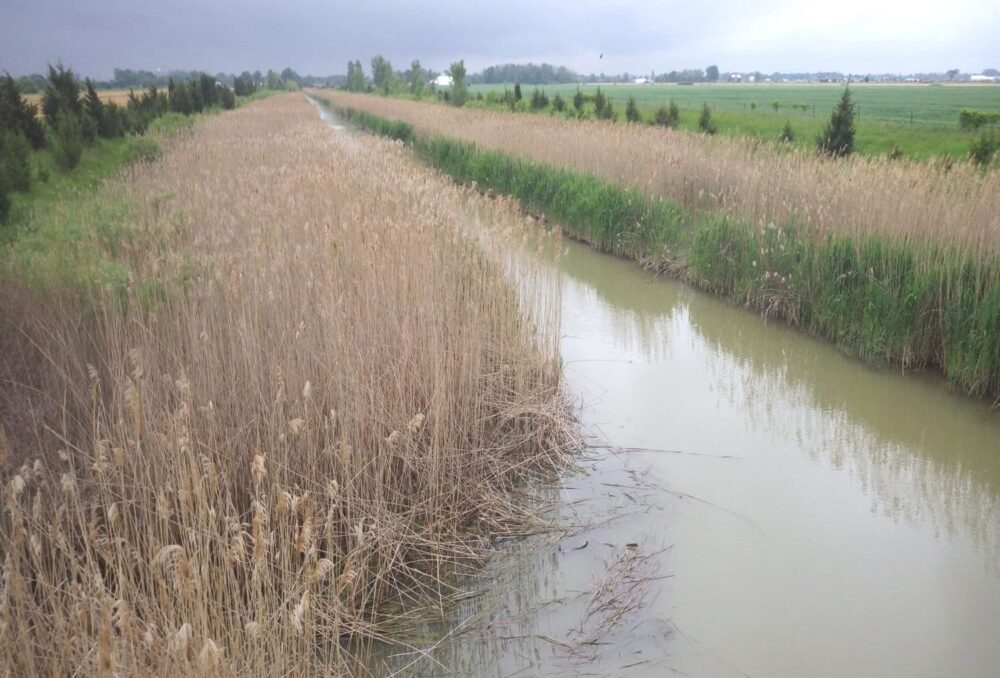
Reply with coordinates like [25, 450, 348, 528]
[316, 93, 1000, 396]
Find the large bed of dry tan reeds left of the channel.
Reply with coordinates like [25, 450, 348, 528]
[0, 95, 573, 676]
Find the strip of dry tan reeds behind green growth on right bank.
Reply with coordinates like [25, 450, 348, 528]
[316, 91, 1000, 256]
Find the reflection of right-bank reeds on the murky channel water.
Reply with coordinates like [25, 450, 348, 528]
[552, 245, 1000, 573]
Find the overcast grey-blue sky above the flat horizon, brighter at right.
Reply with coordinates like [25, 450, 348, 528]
[0, 0, 1000, 78]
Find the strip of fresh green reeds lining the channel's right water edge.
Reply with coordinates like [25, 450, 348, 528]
[318, 95, 1000, 397]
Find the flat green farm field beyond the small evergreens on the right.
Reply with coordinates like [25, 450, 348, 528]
[471, 83, 1000, 160]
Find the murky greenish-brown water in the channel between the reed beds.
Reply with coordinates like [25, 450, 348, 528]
[312, 101, 1000, 677]
